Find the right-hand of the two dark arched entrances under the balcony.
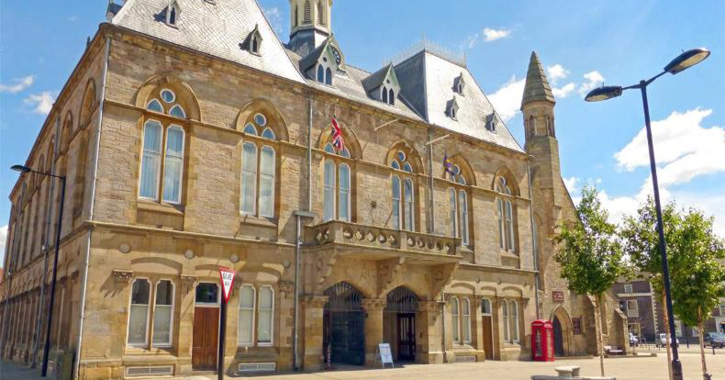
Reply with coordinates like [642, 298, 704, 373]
[383, 286, 418, 362]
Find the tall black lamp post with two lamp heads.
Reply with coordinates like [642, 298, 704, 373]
[585, 48, 710, 380]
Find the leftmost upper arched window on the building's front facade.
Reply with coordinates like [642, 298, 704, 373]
[139, 88, 186, 205]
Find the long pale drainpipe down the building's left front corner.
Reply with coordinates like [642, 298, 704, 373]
[73, 37, 111, 379]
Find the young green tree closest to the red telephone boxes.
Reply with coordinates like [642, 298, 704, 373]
[554, 186, 625, 376]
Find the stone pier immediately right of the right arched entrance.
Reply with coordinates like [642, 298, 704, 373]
[415, 301, 443, 364]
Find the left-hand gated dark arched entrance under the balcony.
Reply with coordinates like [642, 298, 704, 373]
[322, 282, 365, 365]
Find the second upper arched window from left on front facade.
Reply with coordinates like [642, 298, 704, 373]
[239, 113, 277, 219]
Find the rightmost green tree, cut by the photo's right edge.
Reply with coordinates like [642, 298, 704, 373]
[668, 209, 725, 379]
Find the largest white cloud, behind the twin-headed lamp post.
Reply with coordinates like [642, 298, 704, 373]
[614, 108, 725, 187]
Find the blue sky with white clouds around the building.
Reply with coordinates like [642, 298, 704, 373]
[0, 0, 725, 264]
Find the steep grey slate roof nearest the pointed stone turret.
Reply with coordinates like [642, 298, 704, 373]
[395, 49, 523, 152]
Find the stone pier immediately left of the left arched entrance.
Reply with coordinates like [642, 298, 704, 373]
[298, 296, 328, 371]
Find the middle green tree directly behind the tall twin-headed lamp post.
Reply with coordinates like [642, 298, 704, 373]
[619, 197, 680, 379]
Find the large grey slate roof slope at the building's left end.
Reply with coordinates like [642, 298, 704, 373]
[111, 0, 304, 82]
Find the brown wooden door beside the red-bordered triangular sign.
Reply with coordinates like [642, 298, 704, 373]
[191, 307, 219, 370]
